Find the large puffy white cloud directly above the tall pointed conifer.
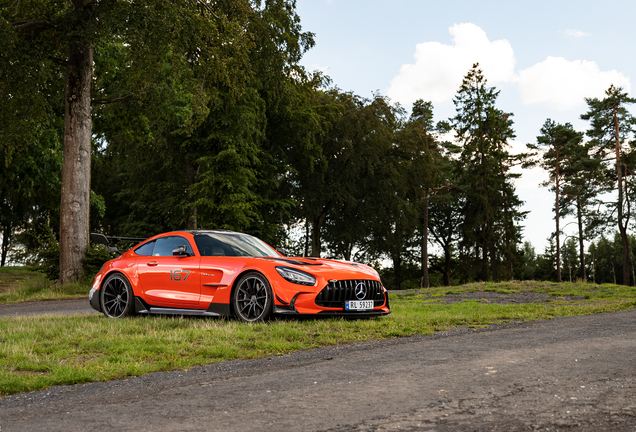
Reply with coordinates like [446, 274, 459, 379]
[387, 23, 516, 104]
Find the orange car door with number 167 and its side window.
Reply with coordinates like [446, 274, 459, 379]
[137, 236, 201, 307]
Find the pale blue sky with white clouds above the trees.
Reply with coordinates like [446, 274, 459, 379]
[297, 0, 636, 253]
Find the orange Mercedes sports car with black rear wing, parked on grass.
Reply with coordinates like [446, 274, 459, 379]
[89, 230, 391, 322]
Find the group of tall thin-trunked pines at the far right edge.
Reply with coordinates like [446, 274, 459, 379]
[528, 85, 636, 285]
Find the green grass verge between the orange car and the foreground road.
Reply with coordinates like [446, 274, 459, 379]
[0, 282, 636, 395]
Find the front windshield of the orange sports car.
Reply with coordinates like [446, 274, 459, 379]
[194, 232, 280, 257]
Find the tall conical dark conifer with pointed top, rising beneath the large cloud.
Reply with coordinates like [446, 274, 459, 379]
[450, 63, 525, 280]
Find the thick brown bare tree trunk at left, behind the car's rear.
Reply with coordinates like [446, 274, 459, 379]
[60, 38, 93, 284]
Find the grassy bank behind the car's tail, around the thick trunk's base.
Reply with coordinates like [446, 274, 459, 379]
[0, 267, 90, 304]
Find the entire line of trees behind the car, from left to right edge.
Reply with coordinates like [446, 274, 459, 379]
[0, 0, 633, 288]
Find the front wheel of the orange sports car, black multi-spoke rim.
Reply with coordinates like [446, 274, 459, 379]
[232, 272, 273, 322]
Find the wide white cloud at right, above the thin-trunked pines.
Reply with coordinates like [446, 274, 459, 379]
[518, 57, 631, 111]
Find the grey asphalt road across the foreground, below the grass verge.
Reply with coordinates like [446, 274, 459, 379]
[0, 309, 636, 432]
